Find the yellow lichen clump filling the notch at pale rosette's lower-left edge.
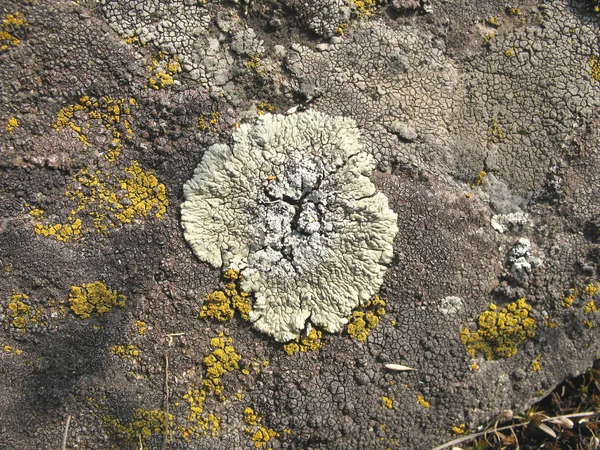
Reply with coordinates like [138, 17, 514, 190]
[200, 268, 252, 322]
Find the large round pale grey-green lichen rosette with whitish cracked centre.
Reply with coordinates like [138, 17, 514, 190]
[181, 111, 398, 342]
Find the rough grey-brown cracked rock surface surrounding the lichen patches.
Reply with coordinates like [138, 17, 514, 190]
[0, 0, 600, 449]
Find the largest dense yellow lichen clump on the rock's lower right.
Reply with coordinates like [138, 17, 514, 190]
[460, 298, 537, 360]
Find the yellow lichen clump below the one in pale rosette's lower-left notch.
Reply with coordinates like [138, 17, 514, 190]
[202, 332, 242, 395]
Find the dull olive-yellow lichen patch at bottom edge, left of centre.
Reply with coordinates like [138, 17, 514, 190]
[103, 408, 173, 448]
